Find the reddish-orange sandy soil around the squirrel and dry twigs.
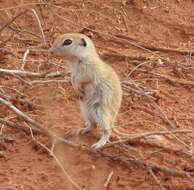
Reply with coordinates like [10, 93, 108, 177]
[0, 0, 194, 190]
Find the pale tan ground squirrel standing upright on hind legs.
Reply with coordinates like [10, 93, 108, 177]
[50, 33, 122, 149]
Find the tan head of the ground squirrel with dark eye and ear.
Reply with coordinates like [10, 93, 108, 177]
[49, 33, 96, 59]
